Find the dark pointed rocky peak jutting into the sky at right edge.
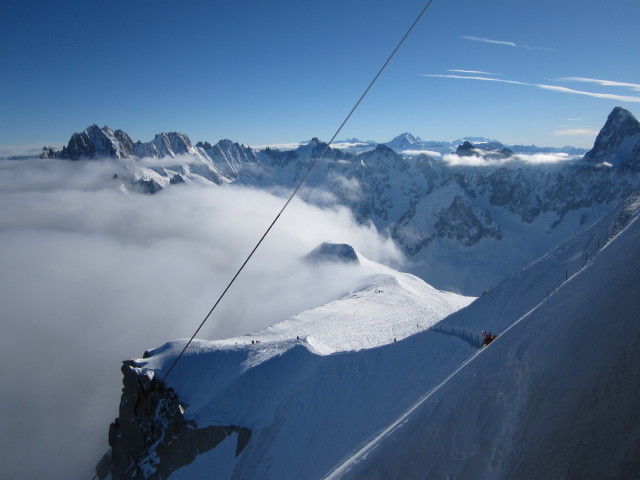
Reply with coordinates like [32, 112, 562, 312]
[584, 107, 640, 166]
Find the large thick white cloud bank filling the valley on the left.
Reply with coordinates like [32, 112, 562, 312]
[0, 160, 402, 478]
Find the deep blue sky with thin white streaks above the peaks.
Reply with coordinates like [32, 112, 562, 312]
[0, 0, 640, 152]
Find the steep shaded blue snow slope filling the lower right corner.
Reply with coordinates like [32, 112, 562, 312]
[327, 192, 640, 479]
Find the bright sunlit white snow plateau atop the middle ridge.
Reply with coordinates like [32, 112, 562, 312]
[200, 257, 474, 369]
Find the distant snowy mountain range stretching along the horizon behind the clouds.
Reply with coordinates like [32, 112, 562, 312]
[38, 107, 640, 295]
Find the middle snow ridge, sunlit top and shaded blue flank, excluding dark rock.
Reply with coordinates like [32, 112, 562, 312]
[117, 249, 473, 478]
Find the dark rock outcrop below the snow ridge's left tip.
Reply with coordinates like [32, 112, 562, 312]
[96, 360, 252, 480]
